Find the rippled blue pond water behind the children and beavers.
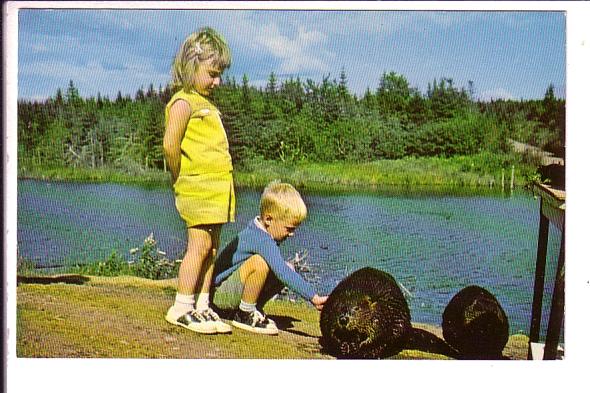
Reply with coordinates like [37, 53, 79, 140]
[17, 180, 560, 333]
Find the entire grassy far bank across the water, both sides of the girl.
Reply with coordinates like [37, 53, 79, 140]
[18, 154, 534, 191]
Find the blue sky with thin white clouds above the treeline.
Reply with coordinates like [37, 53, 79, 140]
[18, 9, 566, 100]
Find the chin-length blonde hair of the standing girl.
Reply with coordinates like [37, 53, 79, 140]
[172, 27, 231, 92]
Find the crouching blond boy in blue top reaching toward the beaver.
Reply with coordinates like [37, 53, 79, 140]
[212, 181, 328, 335]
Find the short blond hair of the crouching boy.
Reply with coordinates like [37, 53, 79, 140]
[260, 180, 307, 223]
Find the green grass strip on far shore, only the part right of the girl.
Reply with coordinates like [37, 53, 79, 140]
[235, 154, 531, 190]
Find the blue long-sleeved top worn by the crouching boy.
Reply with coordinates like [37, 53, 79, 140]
[214, 219, 316, 301]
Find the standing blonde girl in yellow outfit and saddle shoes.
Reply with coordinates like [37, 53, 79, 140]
[164, 28, 235, 334]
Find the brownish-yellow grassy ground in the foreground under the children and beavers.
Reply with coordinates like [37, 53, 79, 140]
[16, 275, 528, 359]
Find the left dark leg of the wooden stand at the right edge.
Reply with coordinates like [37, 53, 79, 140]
[527, 208, 549, 360]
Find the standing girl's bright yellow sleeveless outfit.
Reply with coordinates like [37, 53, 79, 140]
[165, 90, 235, 227]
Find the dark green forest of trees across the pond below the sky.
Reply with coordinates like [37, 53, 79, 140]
[18, 70, 565, 175]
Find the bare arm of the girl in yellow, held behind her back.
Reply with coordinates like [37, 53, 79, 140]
[164, 100, 191, 184]
